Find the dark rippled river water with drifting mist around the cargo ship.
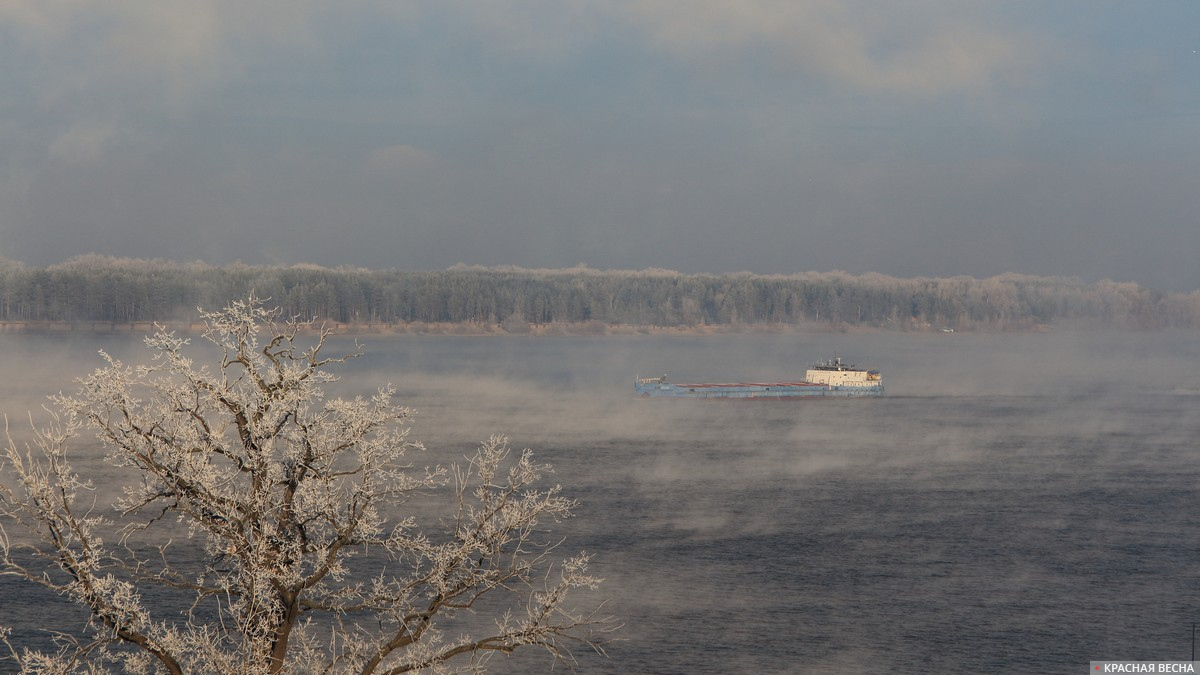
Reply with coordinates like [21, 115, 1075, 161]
[0, 331, 1200, 673]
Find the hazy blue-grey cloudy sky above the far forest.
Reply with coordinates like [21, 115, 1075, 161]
[0, 0, 1200, 291]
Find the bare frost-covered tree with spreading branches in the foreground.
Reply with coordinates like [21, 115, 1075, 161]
[0, 298, 613, 674]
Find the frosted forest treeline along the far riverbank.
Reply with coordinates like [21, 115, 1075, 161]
[0, 255, 1200, 330]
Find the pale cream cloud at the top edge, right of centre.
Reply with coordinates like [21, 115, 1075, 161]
[629, 0, 1032, 94]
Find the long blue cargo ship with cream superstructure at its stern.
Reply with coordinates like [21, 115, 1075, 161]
[634, 358, 883, 400]
